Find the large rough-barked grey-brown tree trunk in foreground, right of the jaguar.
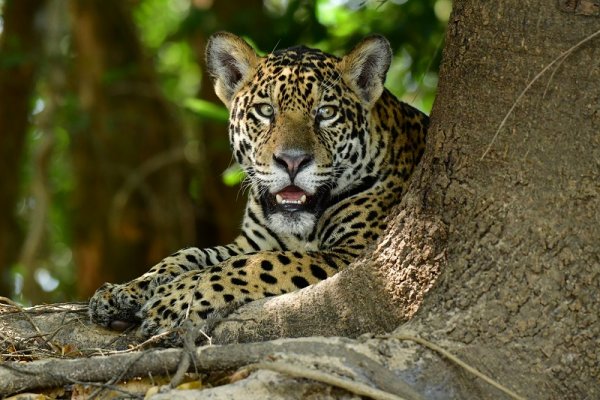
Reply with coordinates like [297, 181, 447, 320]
[394, 0, 600, 399]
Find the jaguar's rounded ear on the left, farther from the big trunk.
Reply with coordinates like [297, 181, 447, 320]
[206, 32, 258, 107]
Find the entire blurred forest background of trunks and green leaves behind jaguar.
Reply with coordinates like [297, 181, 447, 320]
[0, 0, 451, 304]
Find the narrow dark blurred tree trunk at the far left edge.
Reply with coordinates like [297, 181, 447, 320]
[0, 0, 45, 295]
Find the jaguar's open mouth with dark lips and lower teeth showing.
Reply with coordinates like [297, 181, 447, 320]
[261, 185, 327, 214]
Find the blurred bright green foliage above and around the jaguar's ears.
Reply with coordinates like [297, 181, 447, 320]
[135, 0, 451, 112]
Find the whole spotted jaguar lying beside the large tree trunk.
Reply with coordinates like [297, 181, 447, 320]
[89, 32, 428, 336]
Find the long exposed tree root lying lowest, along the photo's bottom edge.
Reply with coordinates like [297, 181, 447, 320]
[0, 338, 420, 399]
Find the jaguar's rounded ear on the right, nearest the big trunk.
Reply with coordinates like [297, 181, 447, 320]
[340, 35, 392, 108]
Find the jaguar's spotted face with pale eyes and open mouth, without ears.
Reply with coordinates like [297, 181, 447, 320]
[207, 33, 392, 235]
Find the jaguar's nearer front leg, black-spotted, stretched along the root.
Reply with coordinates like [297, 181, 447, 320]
[140, 251, 351, 336]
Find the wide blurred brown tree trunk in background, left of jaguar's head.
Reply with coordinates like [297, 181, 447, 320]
[71, 0, 194, 296]
